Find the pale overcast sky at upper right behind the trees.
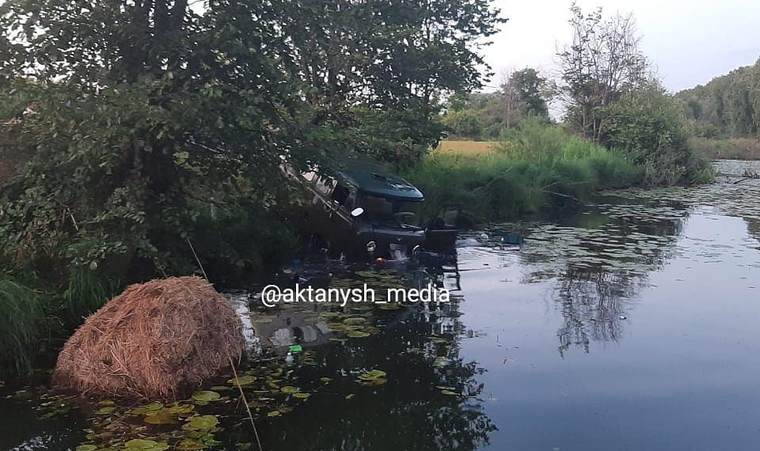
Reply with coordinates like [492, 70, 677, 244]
[485, 0, 760, 91]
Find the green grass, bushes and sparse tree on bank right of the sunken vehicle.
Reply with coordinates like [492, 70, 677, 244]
[418, 5, 712, 221]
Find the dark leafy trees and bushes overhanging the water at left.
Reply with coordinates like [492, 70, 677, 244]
[0, 0, 503, 370]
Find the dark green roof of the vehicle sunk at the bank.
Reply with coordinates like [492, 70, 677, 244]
[337, 160, 425, 201]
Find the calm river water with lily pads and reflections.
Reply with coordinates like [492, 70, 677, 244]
[0, 161, 760, 451]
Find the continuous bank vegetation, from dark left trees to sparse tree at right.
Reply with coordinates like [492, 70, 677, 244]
[0, 0, 732, 380]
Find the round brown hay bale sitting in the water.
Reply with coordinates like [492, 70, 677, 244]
[53, 277, 244, 399]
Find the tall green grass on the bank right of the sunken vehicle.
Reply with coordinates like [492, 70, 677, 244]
[405, 124, 640, 223]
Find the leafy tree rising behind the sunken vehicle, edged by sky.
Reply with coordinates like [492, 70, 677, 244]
[272, 0, 503, 165]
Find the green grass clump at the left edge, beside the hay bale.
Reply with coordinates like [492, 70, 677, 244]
[0, 274, 45, 375]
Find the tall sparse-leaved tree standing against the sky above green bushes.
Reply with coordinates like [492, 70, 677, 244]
[558, 4, 649, 140]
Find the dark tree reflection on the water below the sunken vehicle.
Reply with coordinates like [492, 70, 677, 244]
[230, 259, 496, 450]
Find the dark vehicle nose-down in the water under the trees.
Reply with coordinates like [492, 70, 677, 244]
[288, 160, 456, 259]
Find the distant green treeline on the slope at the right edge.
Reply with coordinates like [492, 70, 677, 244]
[676, 60, 760, 138]
